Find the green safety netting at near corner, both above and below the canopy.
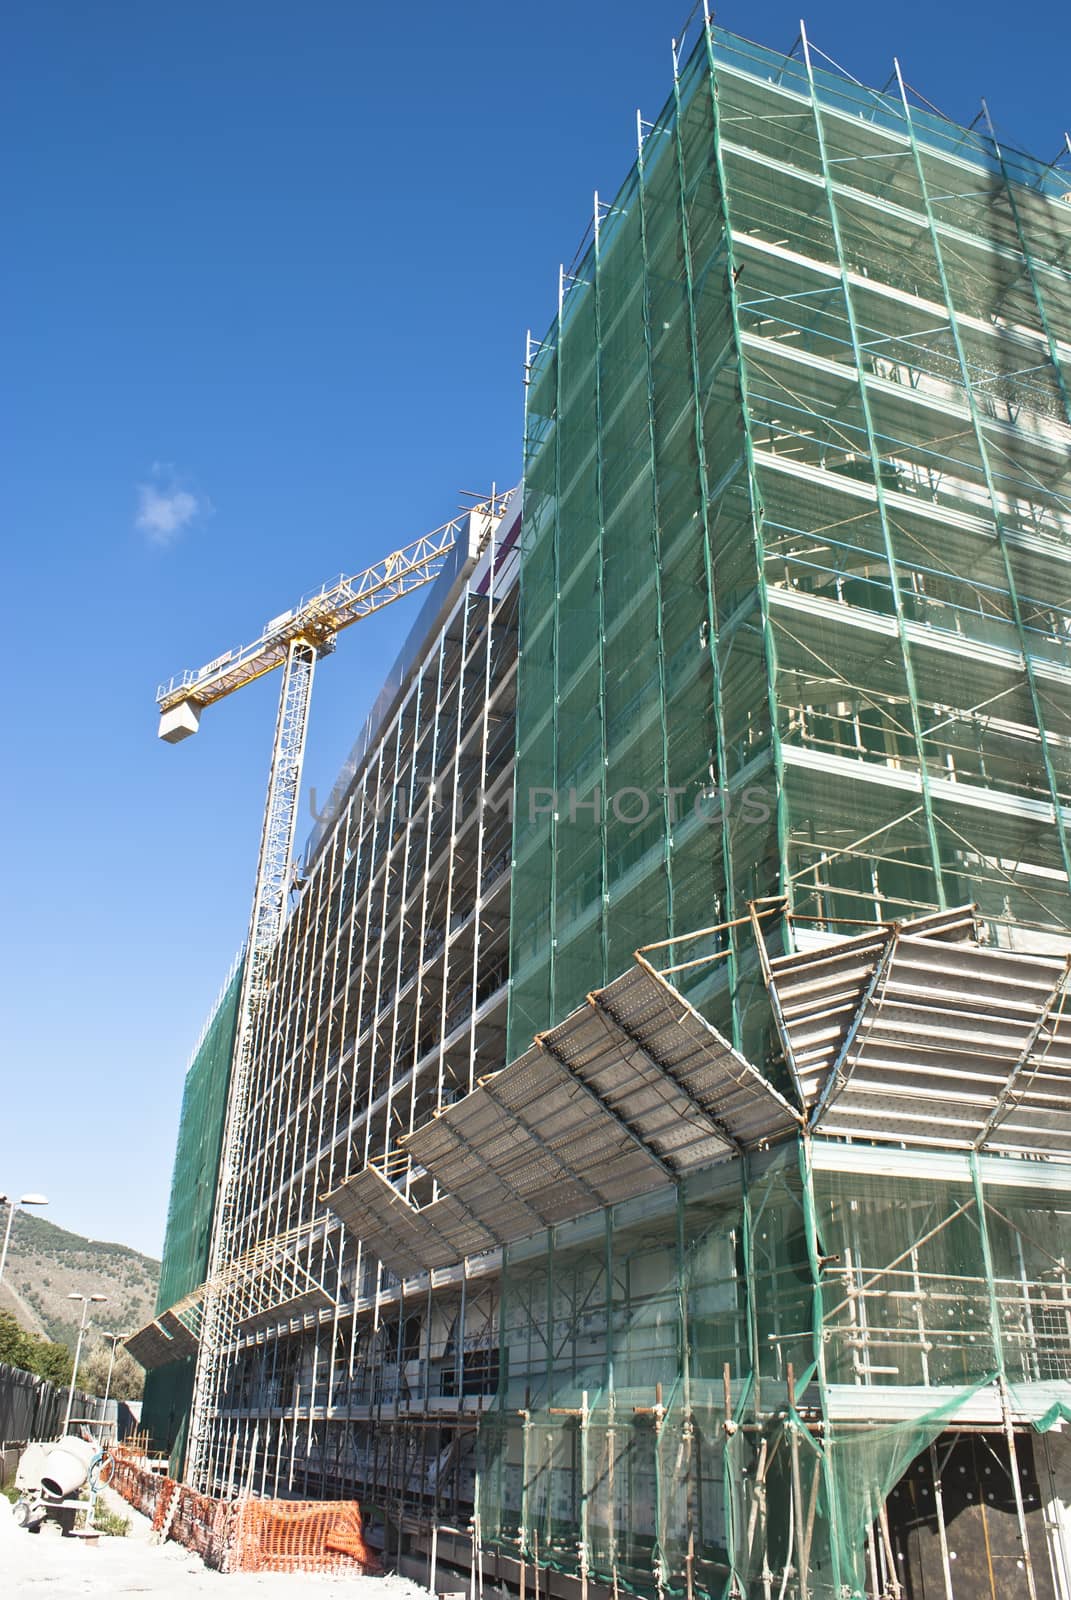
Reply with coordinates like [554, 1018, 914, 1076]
[502, 29, 1071, 1574]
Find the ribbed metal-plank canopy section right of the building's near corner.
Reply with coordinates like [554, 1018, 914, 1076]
[772, 914, 1071, 1155]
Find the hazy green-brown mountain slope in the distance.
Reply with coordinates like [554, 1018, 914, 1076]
[0, 1211, 160, 1350]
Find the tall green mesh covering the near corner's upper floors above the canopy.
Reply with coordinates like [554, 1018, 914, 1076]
[509, 29, 1071, 1059]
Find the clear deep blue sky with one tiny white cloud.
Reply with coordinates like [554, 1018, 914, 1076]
[0, 0, 1071, 1253]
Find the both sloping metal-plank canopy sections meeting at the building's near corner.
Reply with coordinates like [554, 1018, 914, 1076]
[323, 902, 1071, 1275]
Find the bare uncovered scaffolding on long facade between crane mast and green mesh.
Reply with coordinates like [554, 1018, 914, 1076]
[134, 502, 517, 1493]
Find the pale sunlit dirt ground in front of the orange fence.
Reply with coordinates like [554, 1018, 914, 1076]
[0, 1490, 431, 1600]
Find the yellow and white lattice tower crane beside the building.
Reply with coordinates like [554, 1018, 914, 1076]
[157, 488, 509, 1493]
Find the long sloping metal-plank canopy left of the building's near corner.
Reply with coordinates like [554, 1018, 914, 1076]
[323, 962, 800, 1275]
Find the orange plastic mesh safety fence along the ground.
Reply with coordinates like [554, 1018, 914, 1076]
[112, 1446, 379, 1573]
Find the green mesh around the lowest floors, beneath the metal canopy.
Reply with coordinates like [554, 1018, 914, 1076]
[477, 1142, 1071, 1600]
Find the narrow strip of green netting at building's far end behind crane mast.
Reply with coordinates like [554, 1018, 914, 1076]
[142, 965, 242, 1459]
